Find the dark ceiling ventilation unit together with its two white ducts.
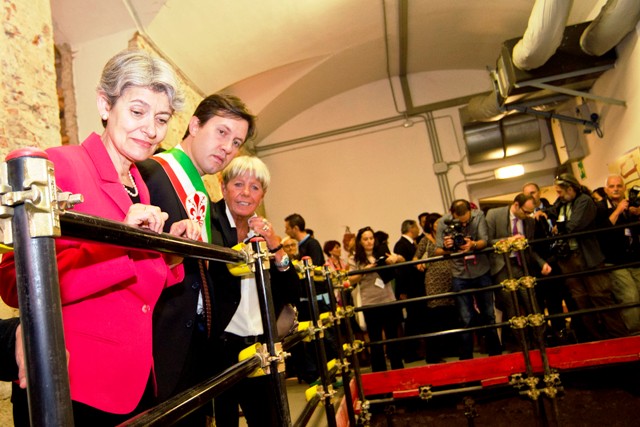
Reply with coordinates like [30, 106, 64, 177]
[467, 0, 640, 121]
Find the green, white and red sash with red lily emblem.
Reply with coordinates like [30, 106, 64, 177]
[152, 147, 211, 243]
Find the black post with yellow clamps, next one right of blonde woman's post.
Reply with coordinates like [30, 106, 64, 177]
[302, 256, 336, 427]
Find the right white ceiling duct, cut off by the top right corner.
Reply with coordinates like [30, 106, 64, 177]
[580, 0, 640, 56]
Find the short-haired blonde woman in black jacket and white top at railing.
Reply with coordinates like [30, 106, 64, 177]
[209, 156, 299, 427]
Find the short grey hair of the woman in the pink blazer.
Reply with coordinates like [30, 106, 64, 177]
[97, 50, 184, 111]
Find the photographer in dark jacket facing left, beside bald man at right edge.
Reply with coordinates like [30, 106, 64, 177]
[548, 173, 628, 340]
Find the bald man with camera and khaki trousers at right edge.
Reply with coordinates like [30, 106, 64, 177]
[598, 175, 640, 332]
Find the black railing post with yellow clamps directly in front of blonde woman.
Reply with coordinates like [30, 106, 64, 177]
[251, 238, 291, 426]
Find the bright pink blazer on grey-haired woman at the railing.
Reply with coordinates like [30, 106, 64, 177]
[0, 133, 184, 414]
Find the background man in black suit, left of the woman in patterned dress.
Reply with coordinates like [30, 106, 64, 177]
[393, 219, 426, 362]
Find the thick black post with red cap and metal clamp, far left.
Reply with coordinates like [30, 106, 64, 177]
[0, 149, 73, 426]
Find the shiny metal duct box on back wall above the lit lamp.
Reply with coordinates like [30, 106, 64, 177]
[463, 114, 542, 165]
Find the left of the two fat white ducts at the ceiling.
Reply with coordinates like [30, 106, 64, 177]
[512, 0, 573, 70]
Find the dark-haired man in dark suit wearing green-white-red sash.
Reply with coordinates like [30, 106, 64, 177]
[137, 94, 255, 425]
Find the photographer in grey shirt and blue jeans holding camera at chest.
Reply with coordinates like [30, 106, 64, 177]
[435, 199, 502, 360]
